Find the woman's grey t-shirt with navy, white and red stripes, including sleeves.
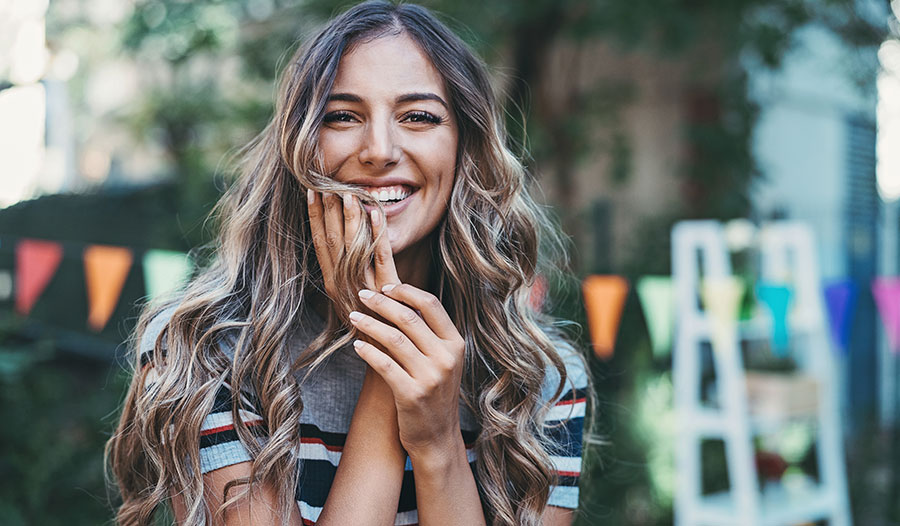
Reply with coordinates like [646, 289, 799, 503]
[140, 310, 587, 525]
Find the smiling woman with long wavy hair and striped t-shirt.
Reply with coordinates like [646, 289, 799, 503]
[107, 2, 586, 525]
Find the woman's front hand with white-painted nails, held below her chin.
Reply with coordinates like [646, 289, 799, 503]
[350, 284, 465, 461]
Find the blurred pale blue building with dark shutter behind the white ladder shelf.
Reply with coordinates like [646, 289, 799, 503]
[750, 13, 892, 434]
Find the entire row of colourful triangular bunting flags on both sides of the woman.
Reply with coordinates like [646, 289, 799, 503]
[0, 234, 900, 350]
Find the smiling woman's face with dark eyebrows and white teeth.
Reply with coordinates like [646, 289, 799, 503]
[319, 33, 458, 255]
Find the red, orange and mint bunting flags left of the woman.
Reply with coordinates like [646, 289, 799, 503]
[0, 238, 193, 332]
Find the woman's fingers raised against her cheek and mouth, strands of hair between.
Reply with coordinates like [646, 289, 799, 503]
[306, 190, 400, 306]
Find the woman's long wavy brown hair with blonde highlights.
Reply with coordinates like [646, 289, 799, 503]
[106, 2, 592, 526]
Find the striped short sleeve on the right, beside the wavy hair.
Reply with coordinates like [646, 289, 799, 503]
[543, 345, 588, 509]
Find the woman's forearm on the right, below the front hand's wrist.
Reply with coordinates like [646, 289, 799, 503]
[410, 436, 485, 526]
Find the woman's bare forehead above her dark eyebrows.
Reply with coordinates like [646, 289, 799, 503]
[332, 33, 447, 100]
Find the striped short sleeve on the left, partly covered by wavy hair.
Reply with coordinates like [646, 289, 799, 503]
[139, 307, 265, 473]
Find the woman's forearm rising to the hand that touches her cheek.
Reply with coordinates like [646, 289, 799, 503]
[316, 370, 406, 526]
